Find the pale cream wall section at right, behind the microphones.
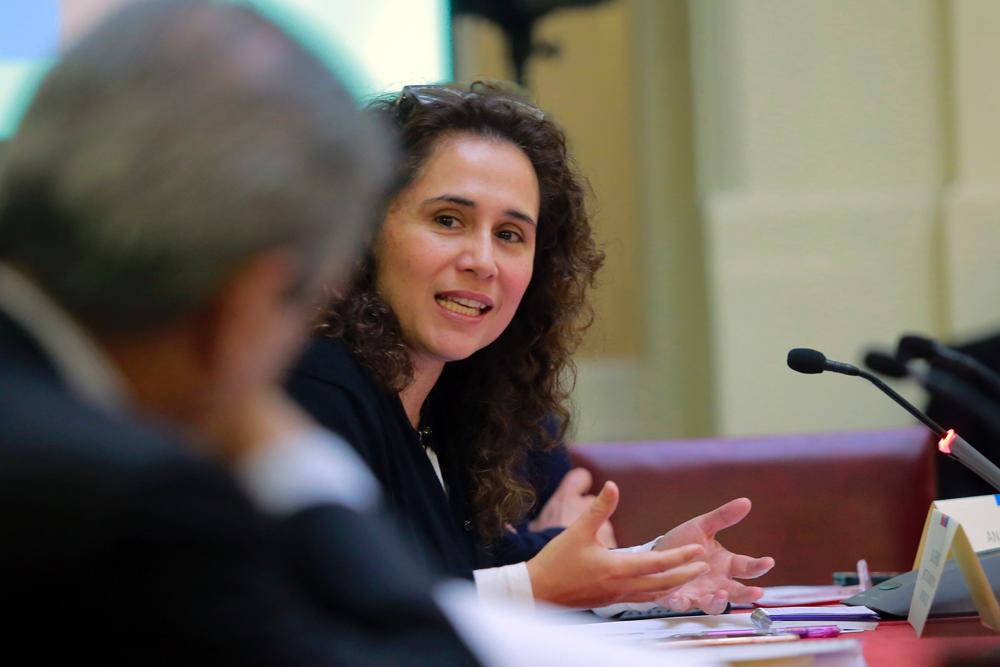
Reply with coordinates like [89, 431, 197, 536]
[691, 0, 1000, 433]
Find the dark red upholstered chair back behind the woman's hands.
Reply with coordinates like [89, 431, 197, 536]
[571, 428, 937, 586]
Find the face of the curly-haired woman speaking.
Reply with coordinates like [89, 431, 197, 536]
[375, 134, 539, 367]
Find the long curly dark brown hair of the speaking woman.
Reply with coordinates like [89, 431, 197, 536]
[321, 83, 604, 543]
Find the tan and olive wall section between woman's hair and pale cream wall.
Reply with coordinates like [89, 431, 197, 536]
[455, 0, 712, 439]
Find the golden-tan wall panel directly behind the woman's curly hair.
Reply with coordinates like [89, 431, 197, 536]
[456, 3, 642, 357]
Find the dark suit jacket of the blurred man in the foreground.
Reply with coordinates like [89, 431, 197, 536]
[0, 314, 475, 665]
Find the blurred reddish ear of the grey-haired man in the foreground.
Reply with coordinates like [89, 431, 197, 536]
[199, 250, 305, 382]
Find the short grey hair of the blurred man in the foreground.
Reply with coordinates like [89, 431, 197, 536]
[0, 0, 393, 333]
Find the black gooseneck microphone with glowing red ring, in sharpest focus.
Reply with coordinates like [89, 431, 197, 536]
[788, 348, 1000, 491]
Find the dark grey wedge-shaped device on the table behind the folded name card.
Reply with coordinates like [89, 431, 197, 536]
[844, 549, 1000, 618]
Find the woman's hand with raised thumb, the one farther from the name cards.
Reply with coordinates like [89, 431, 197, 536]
[527, 482, 710, 608]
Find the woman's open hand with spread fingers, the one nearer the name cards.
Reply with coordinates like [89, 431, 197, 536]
[654, 498, 774, 614]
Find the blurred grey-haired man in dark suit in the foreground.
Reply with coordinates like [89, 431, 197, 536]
[0, 0, 475, 664]
